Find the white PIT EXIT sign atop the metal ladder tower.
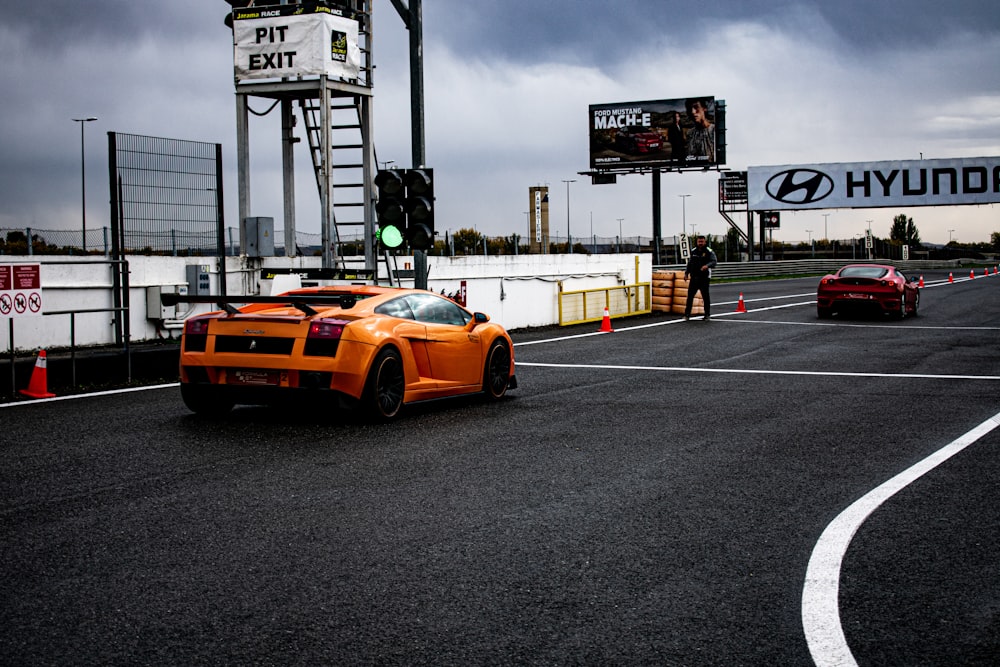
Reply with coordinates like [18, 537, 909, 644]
[233, 4, 361, 81]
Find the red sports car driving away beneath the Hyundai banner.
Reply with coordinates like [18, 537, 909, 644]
[816, 264, 920, 319]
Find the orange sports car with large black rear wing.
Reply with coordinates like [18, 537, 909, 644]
[162, 285, 517, 420]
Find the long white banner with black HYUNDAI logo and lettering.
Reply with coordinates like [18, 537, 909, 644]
[747, 157, 1000, 211]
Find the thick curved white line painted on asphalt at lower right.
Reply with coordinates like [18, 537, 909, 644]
[802, 413, 1000, 667]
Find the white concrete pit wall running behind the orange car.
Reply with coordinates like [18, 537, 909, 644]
[0, 254, 652, 351]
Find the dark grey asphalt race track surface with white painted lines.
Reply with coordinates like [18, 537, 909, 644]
[0, 274, 1000, 665]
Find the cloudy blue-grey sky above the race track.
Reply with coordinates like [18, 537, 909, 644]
[0, 0, 1000, 243]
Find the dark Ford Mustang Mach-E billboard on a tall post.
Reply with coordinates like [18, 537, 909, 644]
[589, 97, 720, 169]
